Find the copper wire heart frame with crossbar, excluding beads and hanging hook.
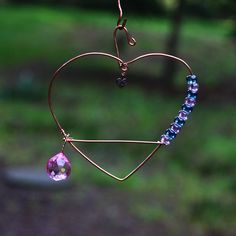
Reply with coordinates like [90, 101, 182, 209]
[48, 52, 193, 181]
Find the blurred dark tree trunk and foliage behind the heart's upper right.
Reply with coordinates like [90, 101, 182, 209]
[160, 0, 236, 88]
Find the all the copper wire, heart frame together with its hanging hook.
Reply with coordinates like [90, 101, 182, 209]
[48, 0, 193, 181]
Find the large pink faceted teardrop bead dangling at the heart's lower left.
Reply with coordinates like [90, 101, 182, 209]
[47, 152, 71, 181]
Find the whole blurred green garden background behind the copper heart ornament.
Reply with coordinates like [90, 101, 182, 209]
[0, 0, 236, 236]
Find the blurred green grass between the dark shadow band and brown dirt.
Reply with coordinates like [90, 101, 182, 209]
[0, 77, 236, 230]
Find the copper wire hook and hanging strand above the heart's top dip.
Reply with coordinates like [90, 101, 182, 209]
[113, 0, 136, 72]
